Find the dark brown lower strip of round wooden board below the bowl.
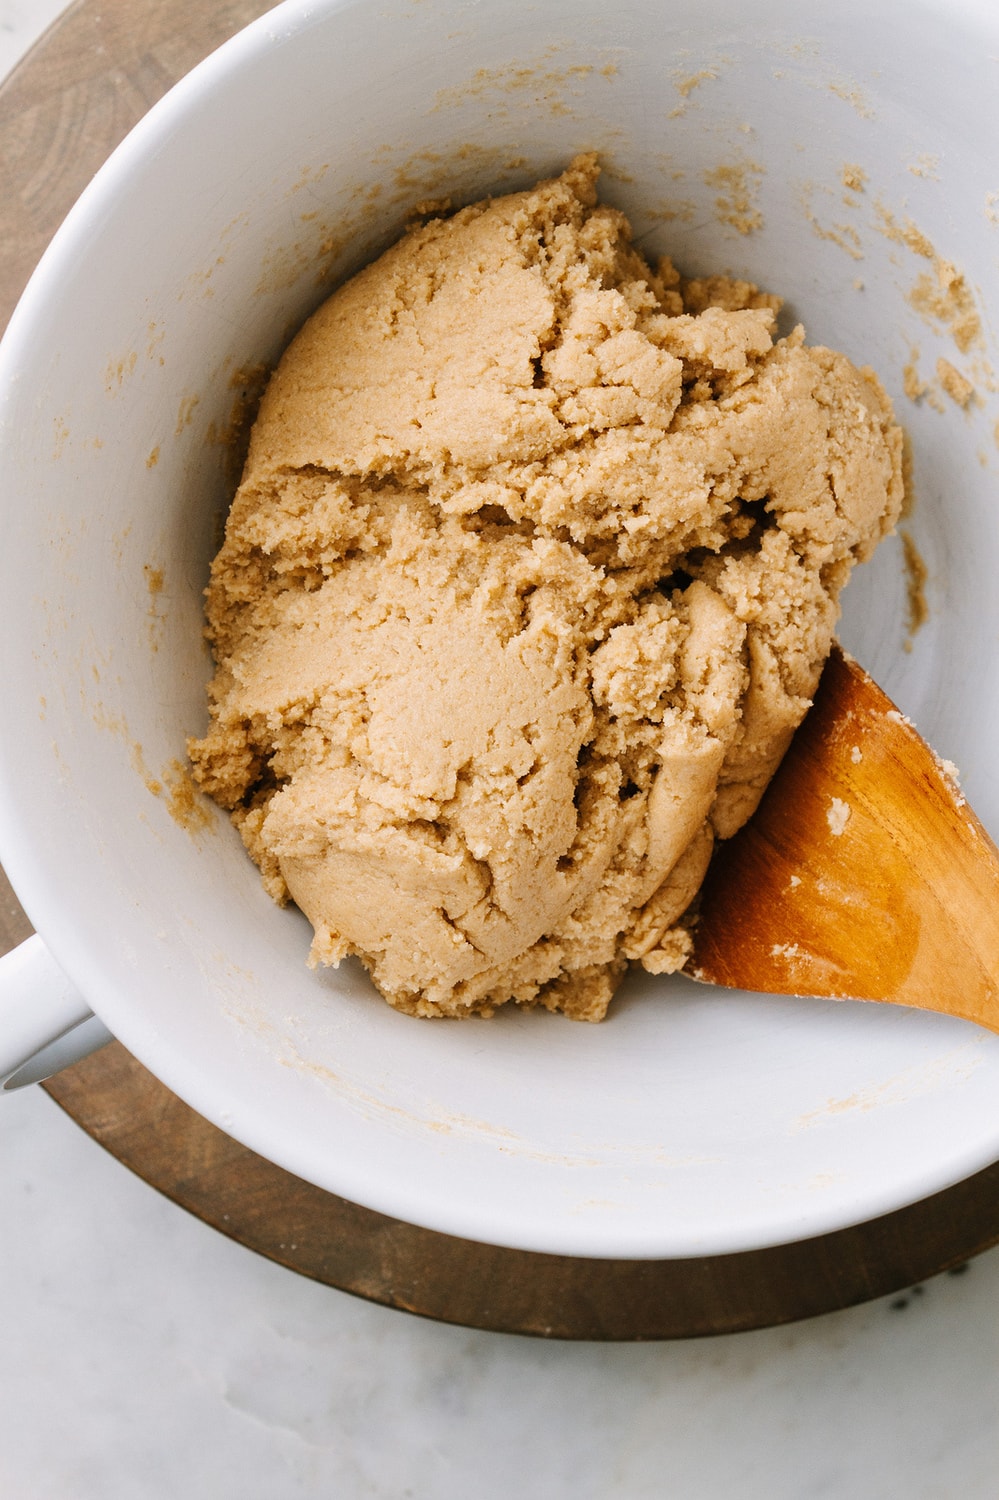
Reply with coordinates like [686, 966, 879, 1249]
[48, 1044, 999, 1341]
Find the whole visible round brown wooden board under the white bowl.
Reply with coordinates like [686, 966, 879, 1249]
[0, 0, 999, 1340]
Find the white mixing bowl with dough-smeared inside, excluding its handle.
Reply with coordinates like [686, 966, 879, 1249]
[0, 0, 999, 1257]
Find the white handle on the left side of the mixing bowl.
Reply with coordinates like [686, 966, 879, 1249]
[0, 933, 114, 1092]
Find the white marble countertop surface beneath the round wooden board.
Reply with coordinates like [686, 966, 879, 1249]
[0, 0, 999, 1500]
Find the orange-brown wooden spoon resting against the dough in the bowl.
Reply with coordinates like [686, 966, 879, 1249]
[687, 647, 999, 1031]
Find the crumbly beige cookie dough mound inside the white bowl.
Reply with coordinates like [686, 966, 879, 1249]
[191, 158, 902, 1020]
